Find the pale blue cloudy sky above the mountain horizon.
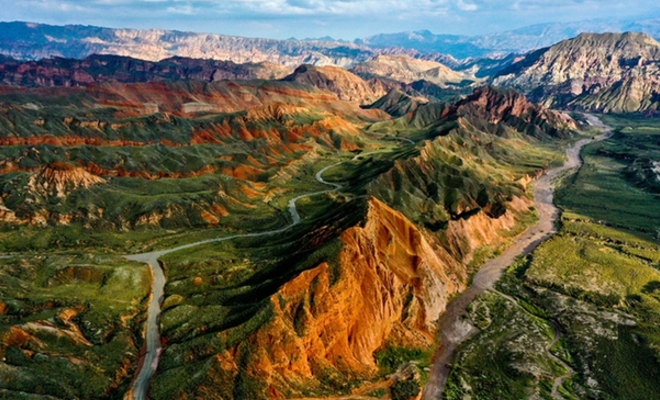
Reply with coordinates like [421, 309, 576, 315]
[0, 0, 660, 40]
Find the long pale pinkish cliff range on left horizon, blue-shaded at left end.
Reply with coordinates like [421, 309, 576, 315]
[0, 22, 374, 67]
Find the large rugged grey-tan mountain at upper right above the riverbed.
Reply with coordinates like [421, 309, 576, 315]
[493, 33, 660, 112]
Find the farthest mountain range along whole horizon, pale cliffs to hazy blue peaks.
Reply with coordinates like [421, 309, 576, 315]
[0, 19, 660, 68]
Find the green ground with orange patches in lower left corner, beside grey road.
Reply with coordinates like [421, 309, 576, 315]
[0, 254, 151, 399]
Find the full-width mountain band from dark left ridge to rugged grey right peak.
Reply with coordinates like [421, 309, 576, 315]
[0, 29, 660, 116]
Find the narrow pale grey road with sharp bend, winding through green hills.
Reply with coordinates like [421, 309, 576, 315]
[124, 148, 402, 400]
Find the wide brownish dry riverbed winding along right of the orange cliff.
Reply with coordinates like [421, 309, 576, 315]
[422, 115, 612, 400]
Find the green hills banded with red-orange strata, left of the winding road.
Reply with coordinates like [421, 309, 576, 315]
[0, 81, 386, 239]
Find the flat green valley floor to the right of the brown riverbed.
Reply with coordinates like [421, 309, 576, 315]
[438, 117, 660, 399]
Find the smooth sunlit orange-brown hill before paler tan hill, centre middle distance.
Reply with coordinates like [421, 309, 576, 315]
[282, 65, 385, 104]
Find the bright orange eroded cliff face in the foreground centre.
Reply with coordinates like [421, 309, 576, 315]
[214, 199, 467, 393]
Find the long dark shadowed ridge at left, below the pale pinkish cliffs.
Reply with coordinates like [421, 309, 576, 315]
[0, 55, 291, 87]
